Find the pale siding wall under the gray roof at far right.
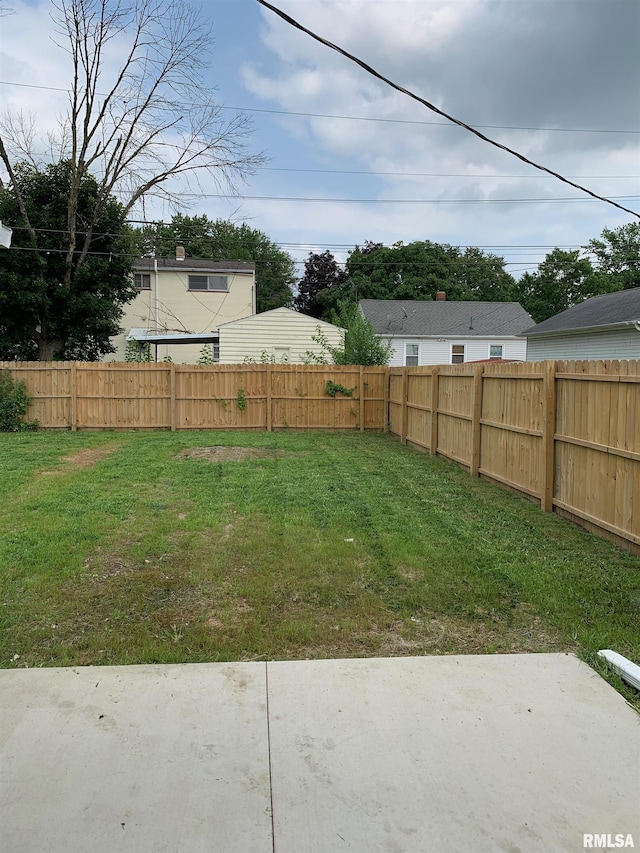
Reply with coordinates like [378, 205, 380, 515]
[527, 328, 640, 361]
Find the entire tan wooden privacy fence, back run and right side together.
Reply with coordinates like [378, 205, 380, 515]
[0, 361, 640, 553]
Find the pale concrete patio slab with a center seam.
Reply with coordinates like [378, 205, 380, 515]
[0, 654, 640, 853]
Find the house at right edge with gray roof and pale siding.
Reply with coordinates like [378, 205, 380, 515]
[522, 287, 640, 361]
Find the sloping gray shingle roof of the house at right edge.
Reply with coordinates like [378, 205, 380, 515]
[523, 287, 640, 338]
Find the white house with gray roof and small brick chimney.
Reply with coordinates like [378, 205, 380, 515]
[360, 293, 531, 367]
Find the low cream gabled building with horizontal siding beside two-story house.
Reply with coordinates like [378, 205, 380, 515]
[220, 308, 342, 364]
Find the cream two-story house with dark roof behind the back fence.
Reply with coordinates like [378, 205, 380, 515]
[111, 244, 256, 363]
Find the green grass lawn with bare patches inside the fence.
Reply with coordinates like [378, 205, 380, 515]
[0, 432, 640, 696]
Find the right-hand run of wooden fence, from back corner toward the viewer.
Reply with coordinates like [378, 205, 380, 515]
[389, 361, 640, 546]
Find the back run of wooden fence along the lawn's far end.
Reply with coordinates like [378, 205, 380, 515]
[0, 362, 388, 430]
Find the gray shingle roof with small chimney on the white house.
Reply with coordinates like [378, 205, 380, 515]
[360, 299, 531, 337]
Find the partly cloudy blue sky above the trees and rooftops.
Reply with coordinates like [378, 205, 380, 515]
[0, 0, 640, 277]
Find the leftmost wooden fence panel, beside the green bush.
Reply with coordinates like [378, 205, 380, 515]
[0, 361, 72, 428]
